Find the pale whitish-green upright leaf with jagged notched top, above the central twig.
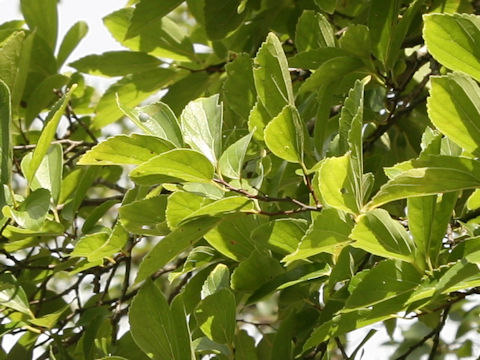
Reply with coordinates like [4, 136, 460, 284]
[180, 95, 223, 164]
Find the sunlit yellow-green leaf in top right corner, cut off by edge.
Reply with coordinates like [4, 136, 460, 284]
[423, 14, 480, 81]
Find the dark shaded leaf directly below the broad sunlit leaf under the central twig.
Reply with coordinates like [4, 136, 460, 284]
[231, 250, 284, 292]
